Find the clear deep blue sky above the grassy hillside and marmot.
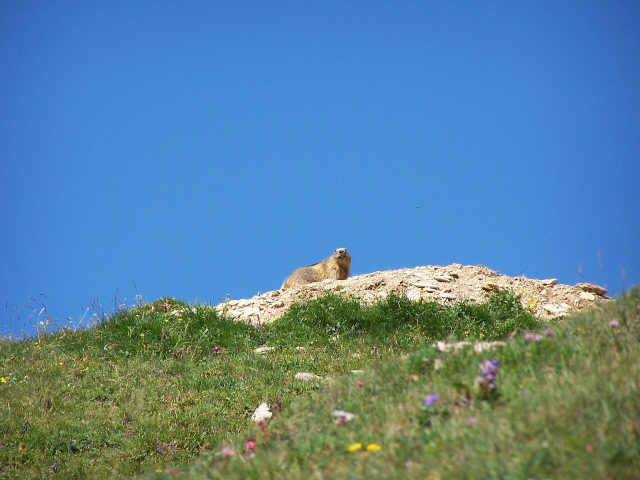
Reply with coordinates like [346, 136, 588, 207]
[0, 0, 640, 334]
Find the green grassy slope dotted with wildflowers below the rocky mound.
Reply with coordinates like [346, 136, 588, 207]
[0, 289, 640, 479]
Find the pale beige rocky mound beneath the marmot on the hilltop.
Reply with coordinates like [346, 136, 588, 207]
[213, 264, 609, 324]
